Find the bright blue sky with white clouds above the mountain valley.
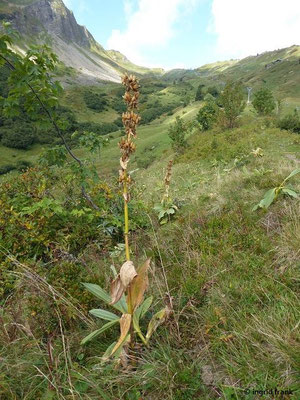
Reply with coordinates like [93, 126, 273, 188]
[65, 0, 300, 69]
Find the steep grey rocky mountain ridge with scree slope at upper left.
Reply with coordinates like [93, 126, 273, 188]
[0, 0, 161, 84]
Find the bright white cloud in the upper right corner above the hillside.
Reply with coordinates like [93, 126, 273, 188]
[210, 0, 300, 58]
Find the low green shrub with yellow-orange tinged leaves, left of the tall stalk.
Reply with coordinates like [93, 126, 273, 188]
[0, 167, 138, 305]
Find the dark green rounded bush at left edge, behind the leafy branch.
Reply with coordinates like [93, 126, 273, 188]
[1, 124, 35, 150]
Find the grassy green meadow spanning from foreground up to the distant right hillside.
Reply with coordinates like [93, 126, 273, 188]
[0, 44, 300, 400]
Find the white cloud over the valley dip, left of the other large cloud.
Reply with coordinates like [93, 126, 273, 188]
[106, 0, 198, 66]
